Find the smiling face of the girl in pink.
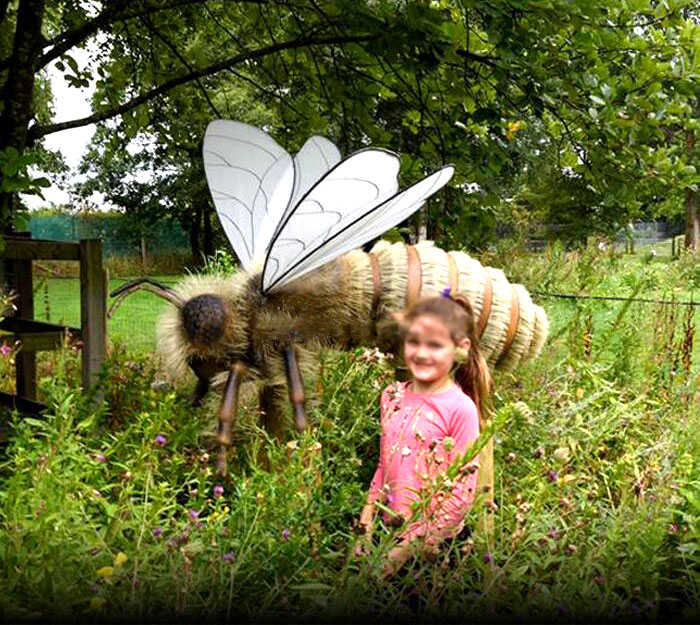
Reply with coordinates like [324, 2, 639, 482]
[404, 315, 470, 391]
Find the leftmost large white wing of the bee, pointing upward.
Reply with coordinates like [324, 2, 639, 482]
[203, 119, 294, 269]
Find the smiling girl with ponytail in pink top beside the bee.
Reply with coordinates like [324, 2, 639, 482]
[358, 289, 491, 577]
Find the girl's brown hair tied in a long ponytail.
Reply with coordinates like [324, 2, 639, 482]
[404, 293, 492, 418]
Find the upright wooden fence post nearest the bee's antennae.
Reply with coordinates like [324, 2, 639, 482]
[80, 239, 107, 389]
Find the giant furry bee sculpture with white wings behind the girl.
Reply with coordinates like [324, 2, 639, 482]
[112, 120, 548, 474]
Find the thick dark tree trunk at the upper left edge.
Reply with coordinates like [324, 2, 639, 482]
[0, 0, 45, 232]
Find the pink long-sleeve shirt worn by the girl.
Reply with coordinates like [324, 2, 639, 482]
[368, 382, 479, 544]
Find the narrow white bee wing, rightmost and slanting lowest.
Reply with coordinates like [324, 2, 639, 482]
[268, 165, 454, 290]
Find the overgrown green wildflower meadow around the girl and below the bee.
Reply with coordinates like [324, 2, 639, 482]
[0, 243, 700, 623]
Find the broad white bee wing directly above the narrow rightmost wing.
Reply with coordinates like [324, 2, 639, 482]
[262, 149, 400, 292]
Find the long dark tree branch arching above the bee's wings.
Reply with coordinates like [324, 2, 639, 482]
[30, 34, 379, 139]
